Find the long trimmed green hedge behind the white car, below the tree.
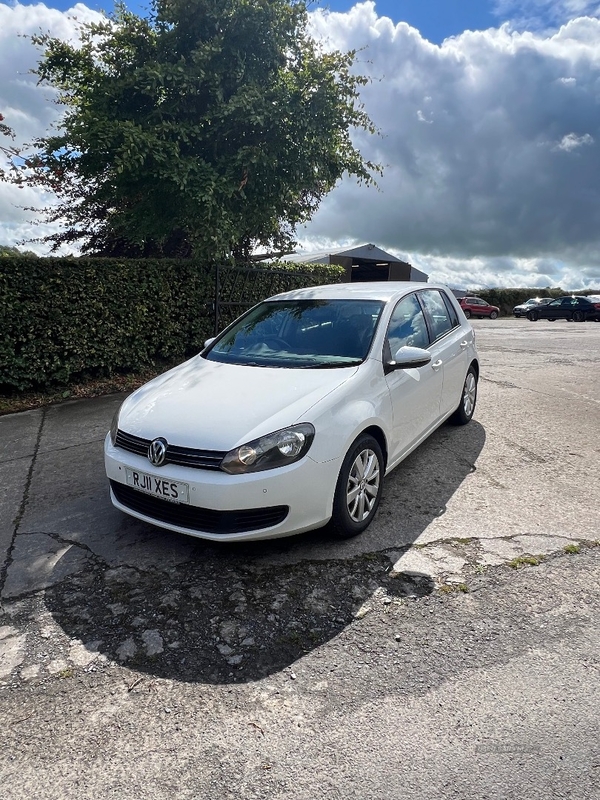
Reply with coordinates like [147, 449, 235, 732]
[0, 256, 343, 391]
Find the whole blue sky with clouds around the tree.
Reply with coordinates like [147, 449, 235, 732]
[0, 0, 600, 291]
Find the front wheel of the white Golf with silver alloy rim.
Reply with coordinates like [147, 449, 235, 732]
[331, 433, 385, 539]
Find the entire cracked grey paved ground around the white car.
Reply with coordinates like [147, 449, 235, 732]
[0, 320, 600, 800]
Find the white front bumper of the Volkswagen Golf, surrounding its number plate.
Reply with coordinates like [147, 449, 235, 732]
[104, 436, 341, 541]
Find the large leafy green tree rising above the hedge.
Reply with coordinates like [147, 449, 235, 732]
[3, 0, 378, 260]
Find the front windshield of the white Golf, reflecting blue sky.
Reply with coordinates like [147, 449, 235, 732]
[204, 300, 384, 369]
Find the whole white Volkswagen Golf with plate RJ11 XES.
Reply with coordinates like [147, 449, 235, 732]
[105, 282, 479, 541]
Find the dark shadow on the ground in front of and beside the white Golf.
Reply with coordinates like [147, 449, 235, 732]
[45, 421, 485, 684]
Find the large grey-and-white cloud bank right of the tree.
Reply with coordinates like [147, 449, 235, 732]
[302, 2, 600, 288]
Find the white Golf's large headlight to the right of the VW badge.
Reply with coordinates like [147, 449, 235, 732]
[221, 422, 315, 475]
